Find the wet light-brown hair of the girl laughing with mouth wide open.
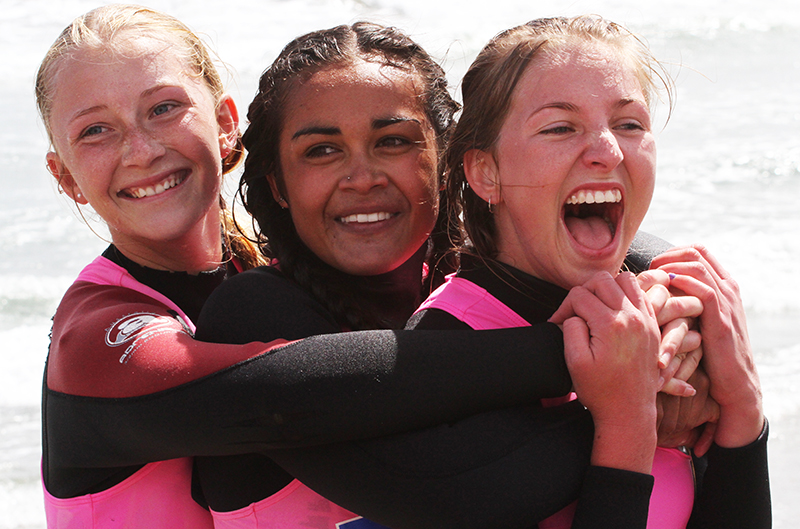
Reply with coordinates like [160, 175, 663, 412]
[446, 15, 673, 259]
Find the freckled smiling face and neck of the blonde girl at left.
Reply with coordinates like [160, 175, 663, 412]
[48, 36, 237, 268]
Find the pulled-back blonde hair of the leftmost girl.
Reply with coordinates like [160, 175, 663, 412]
[35, 4, 263, 268]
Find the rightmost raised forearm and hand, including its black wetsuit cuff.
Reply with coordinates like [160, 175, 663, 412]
[653, 246, 772, 528]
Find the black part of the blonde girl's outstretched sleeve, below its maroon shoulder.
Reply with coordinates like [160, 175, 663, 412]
[46, 324, 571, 468]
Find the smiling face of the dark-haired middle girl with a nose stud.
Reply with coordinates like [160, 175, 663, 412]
[273, 61, 438, 275]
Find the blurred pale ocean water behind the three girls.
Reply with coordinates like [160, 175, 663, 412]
[0, 0, 800, 529]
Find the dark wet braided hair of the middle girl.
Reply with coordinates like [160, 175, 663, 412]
[239, 22, 458, 329]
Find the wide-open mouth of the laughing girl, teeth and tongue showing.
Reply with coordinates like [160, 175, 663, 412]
[563, 189, 623, 250]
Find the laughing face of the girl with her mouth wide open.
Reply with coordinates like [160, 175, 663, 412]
[465, 44, 656, 288]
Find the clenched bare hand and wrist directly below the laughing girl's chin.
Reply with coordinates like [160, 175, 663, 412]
[550, 272, 661, 473]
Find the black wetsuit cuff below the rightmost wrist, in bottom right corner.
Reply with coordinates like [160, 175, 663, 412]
[687, 423, 772, 529]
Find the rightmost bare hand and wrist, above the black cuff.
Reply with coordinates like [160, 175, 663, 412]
[652, 246, 764, 448]
